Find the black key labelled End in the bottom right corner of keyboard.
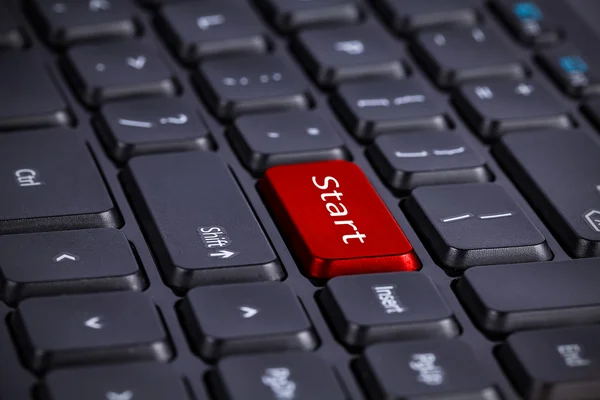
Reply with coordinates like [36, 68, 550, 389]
[498, 326, 600, 400]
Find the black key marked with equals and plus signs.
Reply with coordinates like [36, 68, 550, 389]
[454, 81, 572, 140]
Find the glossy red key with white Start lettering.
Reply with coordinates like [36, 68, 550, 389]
[259, 161, 419, 278]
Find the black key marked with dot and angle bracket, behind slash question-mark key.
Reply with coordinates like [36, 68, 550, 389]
[63, 41, 178, 107]
